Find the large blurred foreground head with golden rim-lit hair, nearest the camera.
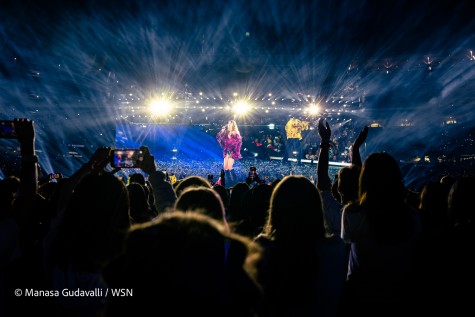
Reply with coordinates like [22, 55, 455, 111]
[106, 211, 258, 316]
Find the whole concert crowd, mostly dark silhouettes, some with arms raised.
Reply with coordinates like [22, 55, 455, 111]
[0, 119, 475, 316]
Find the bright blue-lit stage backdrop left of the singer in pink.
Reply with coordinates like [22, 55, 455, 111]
[116, 124, 222, 160]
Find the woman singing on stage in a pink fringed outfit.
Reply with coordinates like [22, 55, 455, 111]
[216, 120, 242, 186]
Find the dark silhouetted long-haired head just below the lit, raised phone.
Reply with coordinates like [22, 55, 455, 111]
[55, 173, 130, 270]
